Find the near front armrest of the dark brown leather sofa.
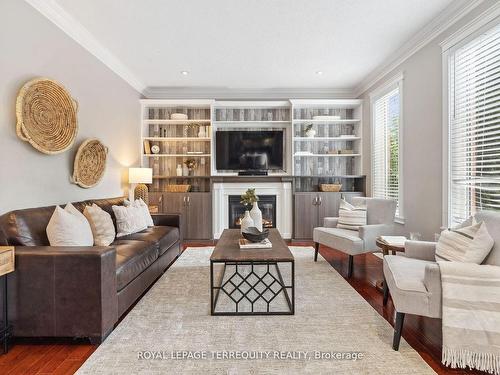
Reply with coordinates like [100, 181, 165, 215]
[9, 246, 118, 340]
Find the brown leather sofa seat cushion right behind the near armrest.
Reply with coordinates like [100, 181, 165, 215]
[111, 238, 158, 291]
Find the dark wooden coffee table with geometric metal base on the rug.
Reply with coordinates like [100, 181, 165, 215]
[210, 229, 295, 315]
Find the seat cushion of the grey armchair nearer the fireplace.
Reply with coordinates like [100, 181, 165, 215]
[313, 227, 364, 255]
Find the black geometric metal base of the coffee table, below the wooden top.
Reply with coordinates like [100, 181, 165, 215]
[210, 260, 295, 316]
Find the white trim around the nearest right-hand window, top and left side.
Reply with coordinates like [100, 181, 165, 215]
[440, 4, 500, 228]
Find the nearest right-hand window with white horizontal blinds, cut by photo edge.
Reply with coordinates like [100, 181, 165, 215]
[447, 25, 500, 226]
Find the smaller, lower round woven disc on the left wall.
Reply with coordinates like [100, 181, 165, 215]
[72, 138, 108, 188]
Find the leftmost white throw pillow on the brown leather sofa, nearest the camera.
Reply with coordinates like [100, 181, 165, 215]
[46, 203, 94, 246]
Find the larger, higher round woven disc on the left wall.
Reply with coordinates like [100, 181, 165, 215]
[16, 78, 78, 154]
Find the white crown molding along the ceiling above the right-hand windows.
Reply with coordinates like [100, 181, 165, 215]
[353, 0, 484, 97]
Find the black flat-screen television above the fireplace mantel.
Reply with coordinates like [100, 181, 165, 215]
[215, 130, 283, 171]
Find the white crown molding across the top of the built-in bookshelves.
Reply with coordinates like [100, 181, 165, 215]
[144, 87, 354, 99]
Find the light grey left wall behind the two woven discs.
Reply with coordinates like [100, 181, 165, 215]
[0, 0, 140, 213]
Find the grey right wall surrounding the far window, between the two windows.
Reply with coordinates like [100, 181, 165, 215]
[361, 0, 496, 240]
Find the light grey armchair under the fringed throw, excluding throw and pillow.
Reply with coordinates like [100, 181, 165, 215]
[384, 211, 500, 350]
